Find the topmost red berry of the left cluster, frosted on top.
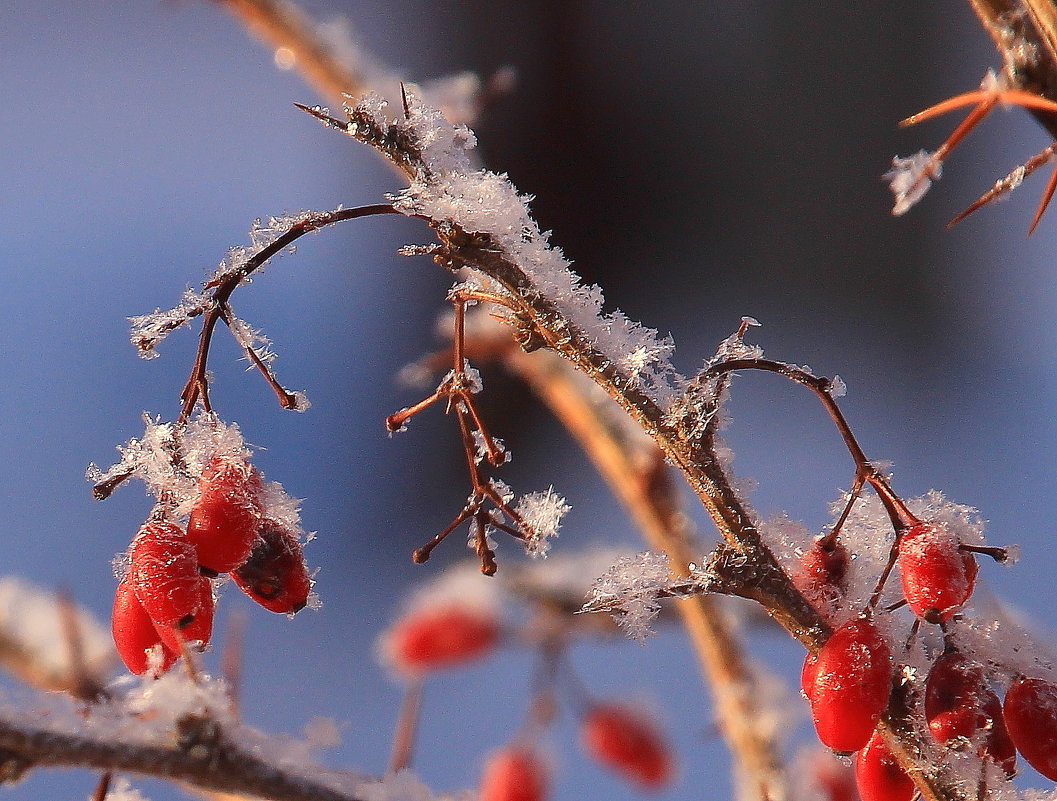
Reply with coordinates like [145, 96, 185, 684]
[187, 455, 261, 573]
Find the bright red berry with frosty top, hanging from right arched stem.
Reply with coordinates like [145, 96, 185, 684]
[897, 523, 978, 623]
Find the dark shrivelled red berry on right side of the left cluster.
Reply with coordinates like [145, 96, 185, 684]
[231, 518, 312, 615]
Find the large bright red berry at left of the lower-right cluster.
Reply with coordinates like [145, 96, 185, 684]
[804, 617, 892, 752]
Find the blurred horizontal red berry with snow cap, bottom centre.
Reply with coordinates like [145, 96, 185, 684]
[386, 606, 499, 673]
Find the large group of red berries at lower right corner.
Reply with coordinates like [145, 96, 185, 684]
[798, 522, 1057, 801]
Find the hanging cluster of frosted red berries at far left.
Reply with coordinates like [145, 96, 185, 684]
[112, 454, 312, 674]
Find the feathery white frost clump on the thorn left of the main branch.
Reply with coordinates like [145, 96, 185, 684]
[585, 551, 672, 644]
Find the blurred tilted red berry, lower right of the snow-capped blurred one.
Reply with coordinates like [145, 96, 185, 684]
[580, 704, 671, 789]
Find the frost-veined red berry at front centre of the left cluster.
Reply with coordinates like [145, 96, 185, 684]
[128, 520, 202, 627]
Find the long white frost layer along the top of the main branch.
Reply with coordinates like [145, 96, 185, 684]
[350, 93, 685, 409]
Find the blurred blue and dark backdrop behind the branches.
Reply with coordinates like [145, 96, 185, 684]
[0, 0, 1057, 801]
